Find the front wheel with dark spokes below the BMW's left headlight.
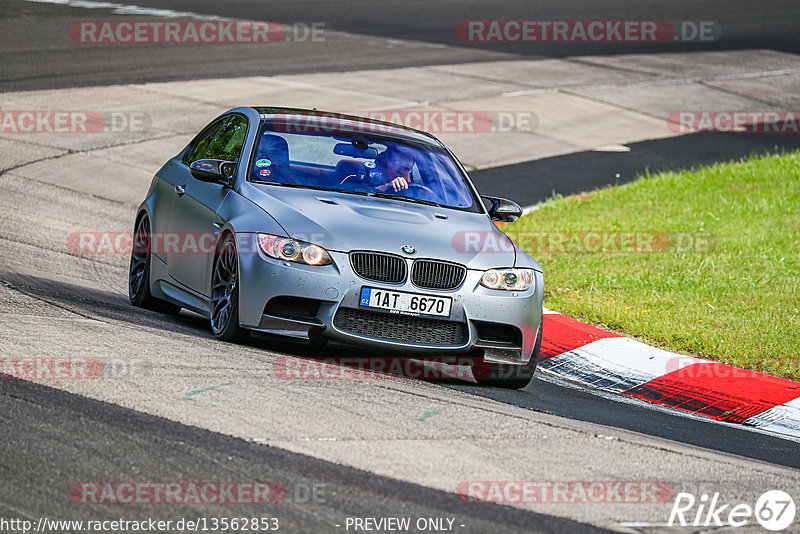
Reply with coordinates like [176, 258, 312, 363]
[210, 234, 247, 342]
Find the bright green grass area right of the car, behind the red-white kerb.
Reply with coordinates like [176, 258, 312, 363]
[503, 153, 800, 379]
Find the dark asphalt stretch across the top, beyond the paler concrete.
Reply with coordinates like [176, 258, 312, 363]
[0, 0, 800, 90]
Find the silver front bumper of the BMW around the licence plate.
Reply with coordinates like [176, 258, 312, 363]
[234, 245, 542, 364]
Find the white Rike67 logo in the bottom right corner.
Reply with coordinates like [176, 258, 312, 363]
[667, 490, 797, 532]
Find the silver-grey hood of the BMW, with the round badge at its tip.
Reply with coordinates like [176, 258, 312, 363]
[245, 184, 517, 269]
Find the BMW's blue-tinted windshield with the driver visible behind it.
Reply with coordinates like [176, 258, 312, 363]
[249, 124, 479, 211]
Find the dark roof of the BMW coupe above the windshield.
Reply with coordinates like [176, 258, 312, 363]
[253, 106, 444, 147]
